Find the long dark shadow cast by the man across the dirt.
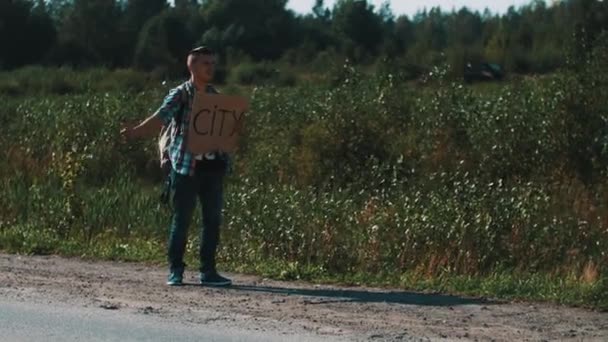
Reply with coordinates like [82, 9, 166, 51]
[227, 285, 496, 306]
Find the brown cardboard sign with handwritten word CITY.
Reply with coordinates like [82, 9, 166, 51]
[188, 93, 249, 154]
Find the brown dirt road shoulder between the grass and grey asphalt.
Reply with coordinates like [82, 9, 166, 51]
[0, 254, 608, 341]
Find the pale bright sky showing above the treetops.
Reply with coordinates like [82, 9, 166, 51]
[287, 0, 531, 17]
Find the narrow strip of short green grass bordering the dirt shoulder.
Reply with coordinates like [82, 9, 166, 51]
[0, 226, 608, 311]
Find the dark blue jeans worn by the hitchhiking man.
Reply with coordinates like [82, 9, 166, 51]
[168, 160, 226, 272]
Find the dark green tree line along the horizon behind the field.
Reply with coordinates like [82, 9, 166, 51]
[0, 0, 608, 74]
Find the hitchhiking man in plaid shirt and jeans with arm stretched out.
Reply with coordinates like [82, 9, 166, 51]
[121, 47, 232, 286]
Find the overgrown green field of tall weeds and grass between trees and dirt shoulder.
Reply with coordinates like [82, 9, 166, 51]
[0, 54, 608, 310]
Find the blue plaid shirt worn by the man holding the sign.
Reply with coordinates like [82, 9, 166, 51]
[155, 80, 229, 175]
